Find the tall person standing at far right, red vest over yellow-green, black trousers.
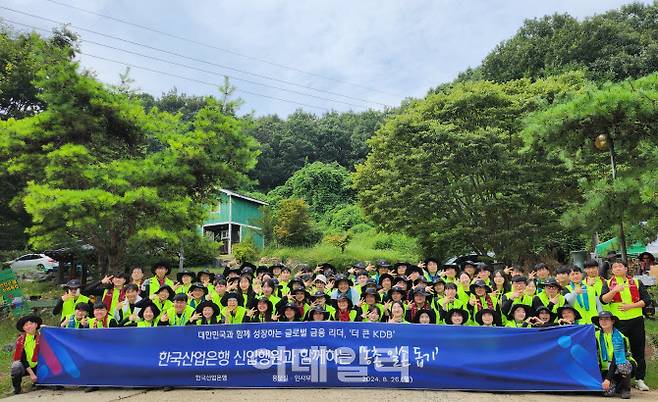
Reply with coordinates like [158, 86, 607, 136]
[600, 261, 651, 391]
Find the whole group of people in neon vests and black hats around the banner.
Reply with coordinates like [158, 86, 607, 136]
[12, 256, 653, 397]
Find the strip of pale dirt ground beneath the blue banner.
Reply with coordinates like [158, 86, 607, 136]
[6, 388, 658, 402]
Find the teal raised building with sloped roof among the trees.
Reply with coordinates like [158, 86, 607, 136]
[202, 189, 267, 254]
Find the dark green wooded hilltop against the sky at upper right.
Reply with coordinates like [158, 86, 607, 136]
[474, 3, 658, 82]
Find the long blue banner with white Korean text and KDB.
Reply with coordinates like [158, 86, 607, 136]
[37, 322, 601, 391]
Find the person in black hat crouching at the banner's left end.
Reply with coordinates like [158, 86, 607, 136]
[11, 315, 43, 394]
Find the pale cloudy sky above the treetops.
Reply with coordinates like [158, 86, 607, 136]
[0, 0, 650, 116]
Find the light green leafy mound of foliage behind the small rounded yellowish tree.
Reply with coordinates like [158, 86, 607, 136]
[267, 162, 354, 220]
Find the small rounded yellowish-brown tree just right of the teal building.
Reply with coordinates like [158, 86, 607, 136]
[274, 198, 321, 246]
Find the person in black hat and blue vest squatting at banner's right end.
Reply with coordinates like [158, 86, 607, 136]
[592, 311, 637, 399]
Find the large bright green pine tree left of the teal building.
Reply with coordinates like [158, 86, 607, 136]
[0, 45, 257, 272]
